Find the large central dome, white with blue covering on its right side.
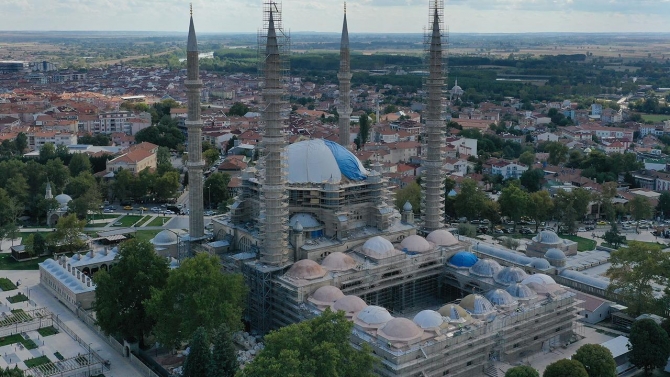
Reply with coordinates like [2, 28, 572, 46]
[286, 139, 368, 183]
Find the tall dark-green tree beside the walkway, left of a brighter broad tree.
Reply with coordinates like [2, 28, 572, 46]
[93, 240, 168, 344]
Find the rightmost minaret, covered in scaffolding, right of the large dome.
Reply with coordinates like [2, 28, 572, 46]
[421, 0, 445, 232]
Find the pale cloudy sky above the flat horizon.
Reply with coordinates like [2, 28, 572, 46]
[0, 0, 670, 33]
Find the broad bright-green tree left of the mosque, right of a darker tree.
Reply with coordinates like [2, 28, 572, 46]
[145, 253, 246, 347]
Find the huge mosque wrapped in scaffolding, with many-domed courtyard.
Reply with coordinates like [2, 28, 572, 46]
[203, 0, 580, 377]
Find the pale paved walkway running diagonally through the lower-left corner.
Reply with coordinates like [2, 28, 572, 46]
[2, 271, 142, 377]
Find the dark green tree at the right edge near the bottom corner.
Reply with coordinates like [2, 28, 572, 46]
[628, 319, 670, 376]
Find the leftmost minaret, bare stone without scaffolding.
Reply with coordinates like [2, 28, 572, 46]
[184, 6, 205, 240]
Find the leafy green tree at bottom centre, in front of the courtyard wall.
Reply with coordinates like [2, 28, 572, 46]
[238, 309, 375, 377]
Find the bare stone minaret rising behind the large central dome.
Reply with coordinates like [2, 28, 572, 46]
[337, 2, 351, 148]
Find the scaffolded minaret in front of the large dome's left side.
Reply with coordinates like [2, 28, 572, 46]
[260, 3, 289, 266]
